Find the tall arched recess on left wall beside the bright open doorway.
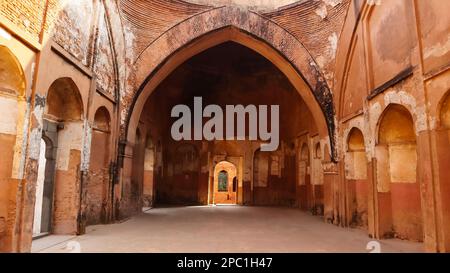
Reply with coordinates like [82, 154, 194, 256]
[43, 78, 84, 234]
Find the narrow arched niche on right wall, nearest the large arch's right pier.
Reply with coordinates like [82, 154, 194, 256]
[344, 128, 369, 229]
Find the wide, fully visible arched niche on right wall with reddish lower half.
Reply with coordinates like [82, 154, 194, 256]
[376, 104, 424, 242]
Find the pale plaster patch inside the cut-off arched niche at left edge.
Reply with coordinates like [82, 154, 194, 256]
[0, 97, 19, 135]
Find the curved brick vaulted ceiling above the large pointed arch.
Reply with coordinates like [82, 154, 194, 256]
[120, 0, 350, 83]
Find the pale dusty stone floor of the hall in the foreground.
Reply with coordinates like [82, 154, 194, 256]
[32, 206, 423, 253]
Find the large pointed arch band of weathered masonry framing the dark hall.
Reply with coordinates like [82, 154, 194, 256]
[122, 7, 336, 160]
